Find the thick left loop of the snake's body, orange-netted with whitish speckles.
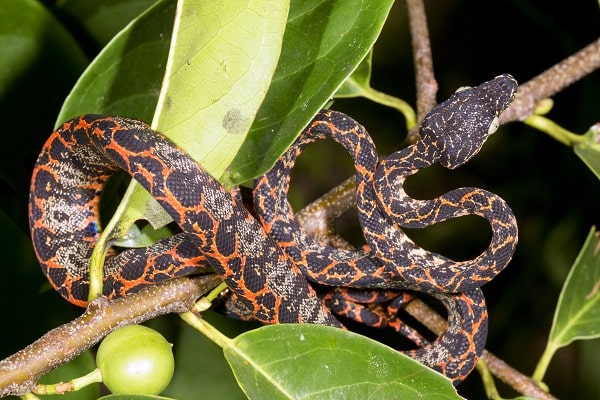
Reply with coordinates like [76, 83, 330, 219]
[29, 115, 341, 326]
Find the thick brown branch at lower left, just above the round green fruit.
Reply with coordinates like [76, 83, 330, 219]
[0, 274, 221, 397]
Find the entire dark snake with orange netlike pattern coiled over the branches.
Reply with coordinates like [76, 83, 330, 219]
[29, 75, 516, 383]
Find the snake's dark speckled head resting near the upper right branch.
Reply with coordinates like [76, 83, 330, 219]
[419, 74, 518, 168]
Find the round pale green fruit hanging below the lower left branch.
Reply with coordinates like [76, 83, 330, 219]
[96, 325, 175, 395]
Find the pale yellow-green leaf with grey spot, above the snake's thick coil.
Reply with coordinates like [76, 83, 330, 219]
[152, 0, 289, 176]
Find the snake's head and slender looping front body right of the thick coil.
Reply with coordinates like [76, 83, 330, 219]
[254, 74, 518, 293]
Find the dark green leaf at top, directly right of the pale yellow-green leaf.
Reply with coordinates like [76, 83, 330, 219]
[220, 0, 393, 185]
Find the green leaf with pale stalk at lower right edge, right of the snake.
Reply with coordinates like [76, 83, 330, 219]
[533, 228, 600, 381]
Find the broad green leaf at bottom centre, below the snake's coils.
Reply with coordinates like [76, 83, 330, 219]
[224, 324, 461, 399]
